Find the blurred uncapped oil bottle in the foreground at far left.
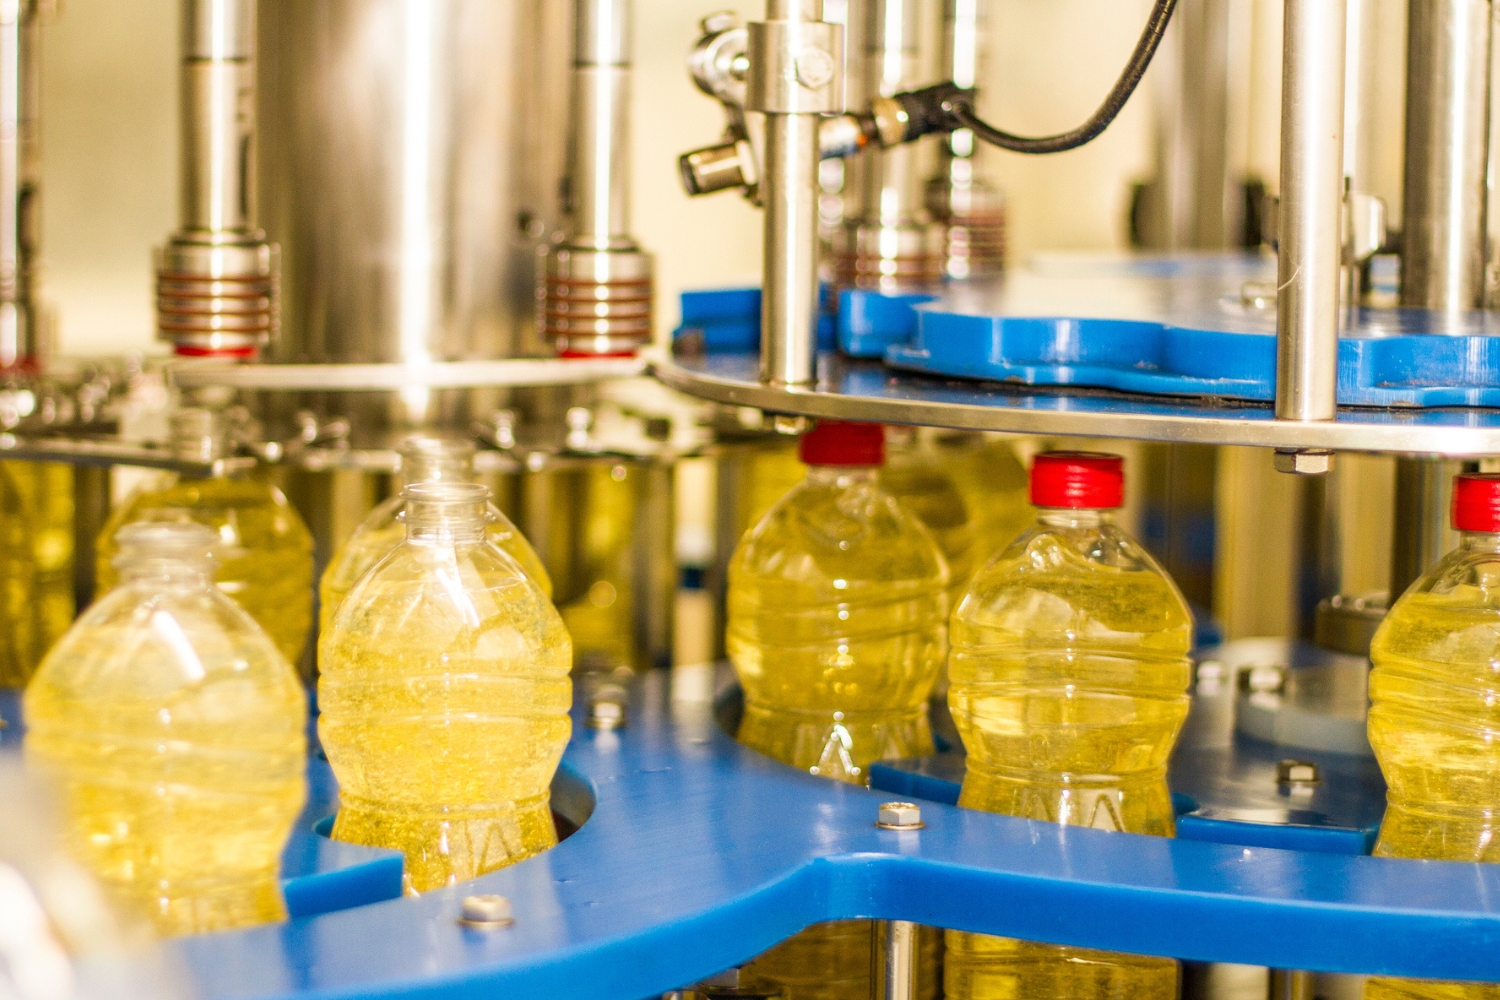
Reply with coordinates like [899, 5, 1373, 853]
[23, 523, 308, 934]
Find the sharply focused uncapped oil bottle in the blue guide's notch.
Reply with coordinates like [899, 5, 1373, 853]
[318, 481, 573, 892]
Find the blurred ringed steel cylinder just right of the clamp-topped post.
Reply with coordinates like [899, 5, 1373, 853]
[833, 0, 945, 292]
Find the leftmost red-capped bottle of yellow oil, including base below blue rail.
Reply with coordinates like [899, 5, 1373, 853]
[726, 421, 948, 1000]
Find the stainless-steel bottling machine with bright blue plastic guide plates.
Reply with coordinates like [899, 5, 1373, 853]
[0, 0, 1500, 1000]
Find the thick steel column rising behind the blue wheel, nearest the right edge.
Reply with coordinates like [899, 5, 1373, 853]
[1401, 0, 1491, 310]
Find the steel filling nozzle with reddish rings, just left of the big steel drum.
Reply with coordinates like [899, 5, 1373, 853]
[156, 0, 278, 357]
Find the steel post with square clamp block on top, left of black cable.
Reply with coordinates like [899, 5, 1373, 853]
[746, 0, 843, 385]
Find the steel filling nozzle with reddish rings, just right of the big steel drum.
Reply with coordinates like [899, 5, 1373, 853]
[539, 0, 654, 357]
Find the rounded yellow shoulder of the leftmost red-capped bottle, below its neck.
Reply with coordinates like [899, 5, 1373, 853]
[731, 481, 948, 595]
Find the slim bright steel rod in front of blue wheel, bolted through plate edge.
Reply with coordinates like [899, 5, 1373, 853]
[1277, 0, 1346, 420]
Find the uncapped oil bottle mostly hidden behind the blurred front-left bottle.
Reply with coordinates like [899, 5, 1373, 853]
[96, 409, 312, 664]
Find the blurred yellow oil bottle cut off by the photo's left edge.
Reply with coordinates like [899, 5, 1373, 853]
[0, 462, 75, 688]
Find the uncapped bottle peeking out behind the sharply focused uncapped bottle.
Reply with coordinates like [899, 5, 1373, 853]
[318, 438, 552, 634]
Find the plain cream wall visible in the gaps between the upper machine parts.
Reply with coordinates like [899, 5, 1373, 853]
[32, 0, 1400, 354]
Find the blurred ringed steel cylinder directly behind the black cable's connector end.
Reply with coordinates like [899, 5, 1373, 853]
[927, 0, 1005, 279]
